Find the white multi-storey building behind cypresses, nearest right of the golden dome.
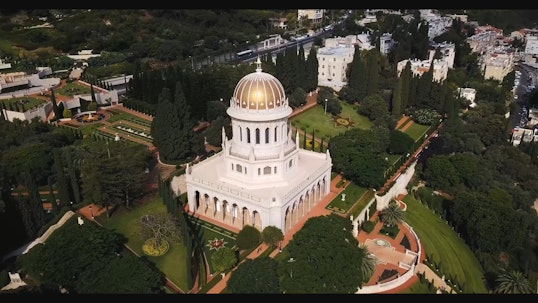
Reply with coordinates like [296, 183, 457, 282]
[317, 46, 355, 91]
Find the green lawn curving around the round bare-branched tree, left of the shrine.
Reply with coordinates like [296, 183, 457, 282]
[97, 197, 190, 291]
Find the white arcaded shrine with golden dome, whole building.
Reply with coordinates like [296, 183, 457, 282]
[186, 58, 332, 233]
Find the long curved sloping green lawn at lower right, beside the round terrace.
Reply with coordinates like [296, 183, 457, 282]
[403, 195, 488, 294]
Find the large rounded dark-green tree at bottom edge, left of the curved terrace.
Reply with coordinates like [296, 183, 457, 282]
[279, 215, 369, 294]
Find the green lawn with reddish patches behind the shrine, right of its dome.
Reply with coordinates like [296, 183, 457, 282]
[289, 102, 372, 141]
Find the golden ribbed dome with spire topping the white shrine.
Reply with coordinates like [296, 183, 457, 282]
[233, 58, 287, 110]
